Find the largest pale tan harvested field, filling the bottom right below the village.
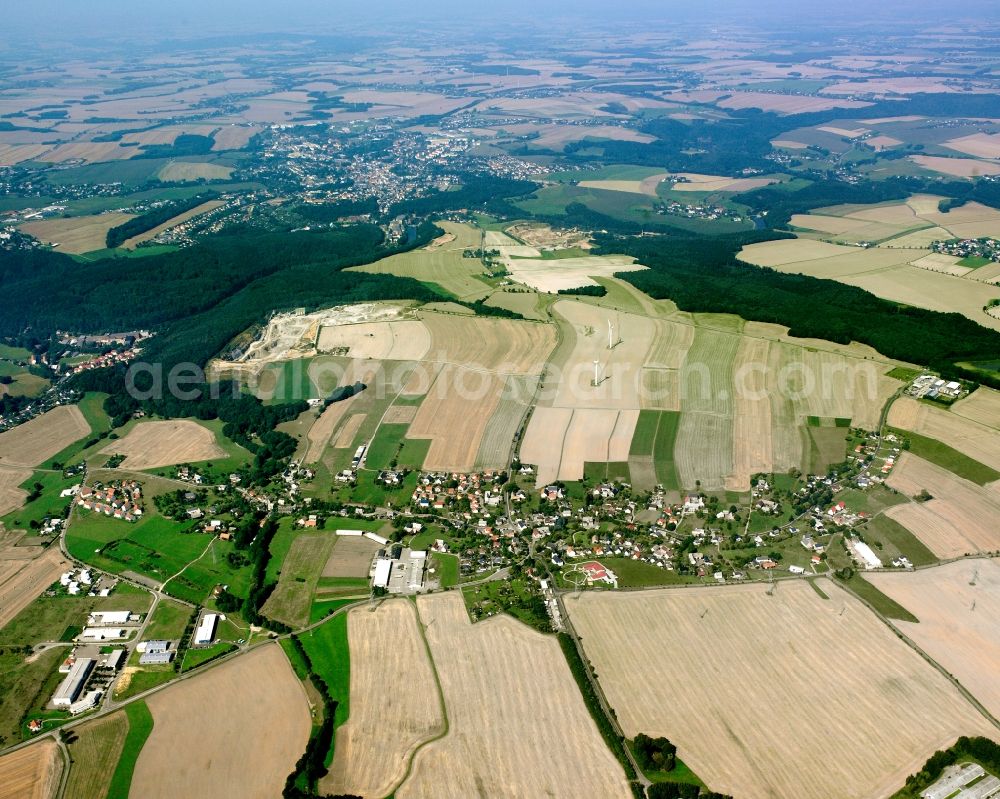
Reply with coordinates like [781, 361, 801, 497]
[567, 579, 995, 799]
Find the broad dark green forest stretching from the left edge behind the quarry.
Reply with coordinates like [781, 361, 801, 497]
[0, 219, 440, 365]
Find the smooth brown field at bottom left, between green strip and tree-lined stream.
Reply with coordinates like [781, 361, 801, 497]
[130, 644, 312, 799]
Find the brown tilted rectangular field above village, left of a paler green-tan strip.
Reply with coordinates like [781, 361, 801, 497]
[406, 365, 505, 472]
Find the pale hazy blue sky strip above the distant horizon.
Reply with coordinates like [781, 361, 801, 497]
[0, 0, 1000, 47]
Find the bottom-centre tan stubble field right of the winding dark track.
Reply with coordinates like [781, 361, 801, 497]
[395, 593, 632, 799]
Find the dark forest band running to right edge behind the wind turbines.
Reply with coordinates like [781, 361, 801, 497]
[598, 231, 1000, 382]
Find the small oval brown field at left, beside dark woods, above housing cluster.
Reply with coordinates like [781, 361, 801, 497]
[101, 419, 226, 469]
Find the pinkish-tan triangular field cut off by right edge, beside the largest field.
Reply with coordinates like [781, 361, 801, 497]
[865, 558, 1000, 716]
